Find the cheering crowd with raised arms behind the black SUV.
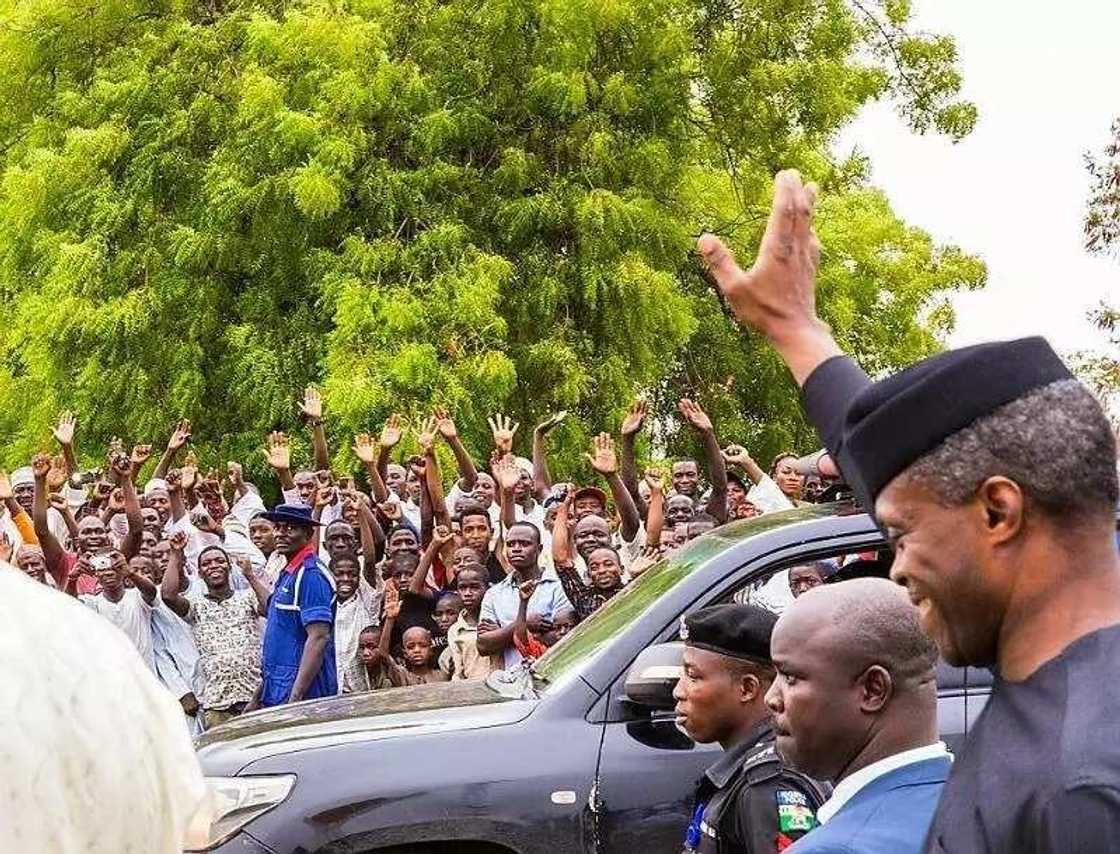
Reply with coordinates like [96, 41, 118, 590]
[0, 388, 824, 731]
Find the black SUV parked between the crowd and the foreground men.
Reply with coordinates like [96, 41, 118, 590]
[190, 505, 991, 854]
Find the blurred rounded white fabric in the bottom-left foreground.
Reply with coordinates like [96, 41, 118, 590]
[0, 564, 206, 854]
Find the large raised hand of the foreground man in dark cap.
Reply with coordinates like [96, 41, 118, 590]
[697, 169, 823, 343]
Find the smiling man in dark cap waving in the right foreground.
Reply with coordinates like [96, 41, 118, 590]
[699, 171, 1120, 852]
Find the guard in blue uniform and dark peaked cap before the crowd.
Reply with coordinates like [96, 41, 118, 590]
[261, 504, 338, 706]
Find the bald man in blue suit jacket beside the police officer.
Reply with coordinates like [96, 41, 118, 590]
[766, 578, 952, 854]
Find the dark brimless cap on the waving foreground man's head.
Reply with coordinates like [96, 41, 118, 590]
[842, 337, 1073, 501]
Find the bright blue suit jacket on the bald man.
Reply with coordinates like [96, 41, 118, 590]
[787, 758, 952, 854]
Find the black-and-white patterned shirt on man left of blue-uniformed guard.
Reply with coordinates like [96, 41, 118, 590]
[187, 591, 261, 709]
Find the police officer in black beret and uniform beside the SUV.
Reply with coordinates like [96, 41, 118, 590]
[673, 605, 827, 854]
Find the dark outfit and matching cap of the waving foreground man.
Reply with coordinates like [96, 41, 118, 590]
[803, 337, 1120, 854]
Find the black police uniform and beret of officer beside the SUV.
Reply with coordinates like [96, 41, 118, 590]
[681, 605, 829, 854]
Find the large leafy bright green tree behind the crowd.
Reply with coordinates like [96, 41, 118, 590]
[0, 0, 986, 479]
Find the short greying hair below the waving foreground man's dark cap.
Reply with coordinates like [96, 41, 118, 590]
[903, 380, 1120, 518]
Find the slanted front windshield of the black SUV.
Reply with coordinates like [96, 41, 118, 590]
[532, 504, 841, 694]
